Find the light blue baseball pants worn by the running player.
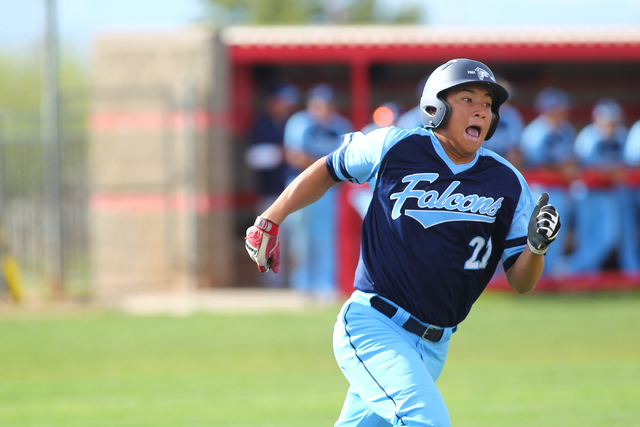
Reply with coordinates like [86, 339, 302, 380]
[333, 291, 454, 427]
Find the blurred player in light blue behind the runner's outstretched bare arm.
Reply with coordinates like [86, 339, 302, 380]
[284, 84, 353, 302]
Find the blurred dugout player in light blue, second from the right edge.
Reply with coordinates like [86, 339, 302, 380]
[568, 98, 640, 273]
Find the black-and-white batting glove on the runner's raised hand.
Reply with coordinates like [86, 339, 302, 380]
[527, 192, 560, 255]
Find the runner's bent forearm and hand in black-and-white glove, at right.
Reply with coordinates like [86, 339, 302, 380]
[506, 193, 560, 294]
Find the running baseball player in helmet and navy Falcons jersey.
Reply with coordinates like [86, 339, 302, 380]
[246, 59, 560, 427]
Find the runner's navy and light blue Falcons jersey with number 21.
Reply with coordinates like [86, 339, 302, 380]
[327, 127, 533, 327]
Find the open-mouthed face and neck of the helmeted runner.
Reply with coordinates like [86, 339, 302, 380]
[435, 86, 493, 164]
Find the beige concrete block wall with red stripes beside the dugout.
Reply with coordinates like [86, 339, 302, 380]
[90, 29, 233, 298]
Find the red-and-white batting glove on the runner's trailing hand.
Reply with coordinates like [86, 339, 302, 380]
[244, 216, 280, 273]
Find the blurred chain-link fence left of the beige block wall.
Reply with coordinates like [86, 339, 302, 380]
[0, 100, 90, 296]
